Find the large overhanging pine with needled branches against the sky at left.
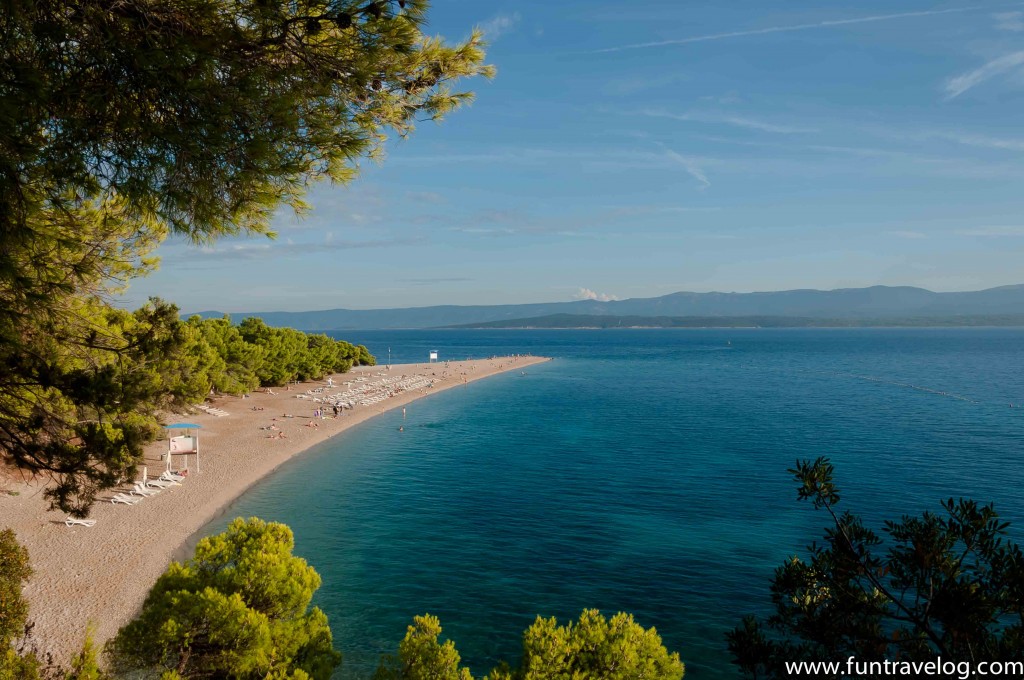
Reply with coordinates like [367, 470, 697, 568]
[0, 0, 494, 515]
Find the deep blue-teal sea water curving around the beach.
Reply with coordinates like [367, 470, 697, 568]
[197, 329, 1024, 679]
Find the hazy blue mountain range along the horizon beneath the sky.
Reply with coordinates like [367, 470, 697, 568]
[192, 285, 1024, 331]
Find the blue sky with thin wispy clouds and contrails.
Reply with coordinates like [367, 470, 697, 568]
[124, 0, 1024, 312]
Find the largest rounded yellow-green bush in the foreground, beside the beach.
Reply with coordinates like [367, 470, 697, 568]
[108, 517, 341, 680]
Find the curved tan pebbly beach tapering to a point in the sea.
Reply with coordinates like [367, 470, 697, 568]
[0, 356, 549, 663]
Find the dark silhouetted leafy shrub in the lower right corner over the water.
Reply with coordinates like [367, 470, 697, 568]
[727, 458, 1024, 678]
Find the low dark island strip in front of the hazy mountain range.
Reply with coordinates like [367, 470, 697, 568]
[444, 314, 1024, 329]
